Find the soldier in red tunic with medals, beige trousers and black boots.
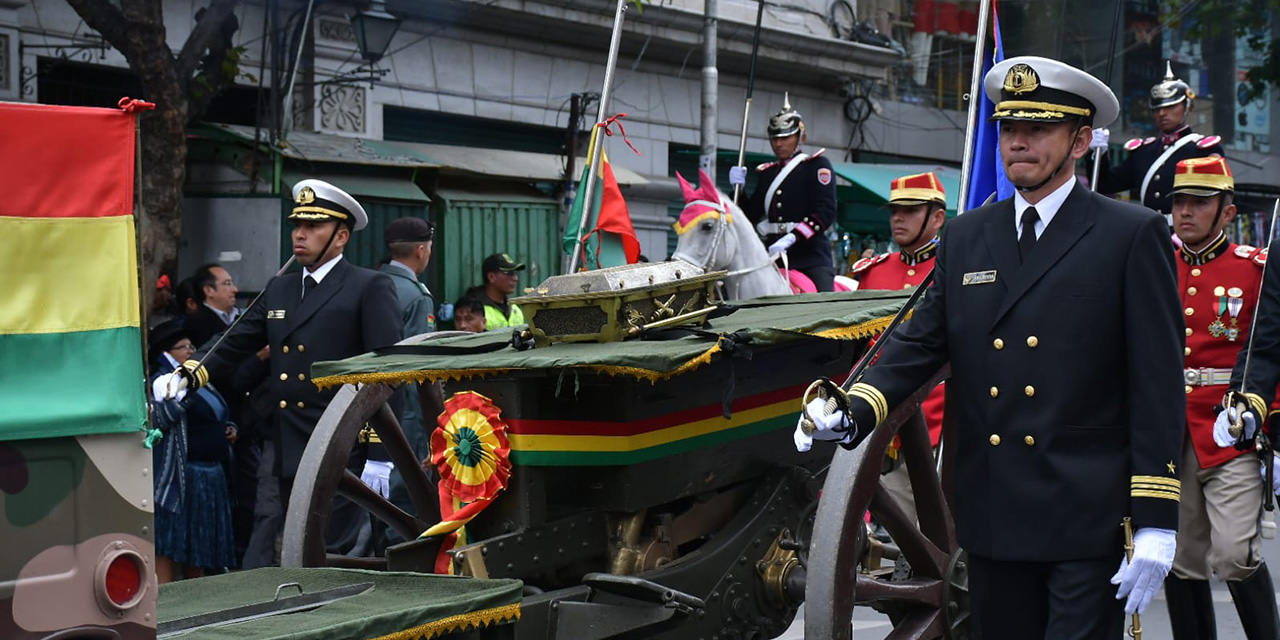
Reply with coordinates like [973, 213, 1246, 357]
[1165, 157, 1280, 640]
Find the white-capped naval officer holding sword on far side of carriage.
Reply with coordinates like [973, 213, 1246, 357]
[157, 179, 402, 553]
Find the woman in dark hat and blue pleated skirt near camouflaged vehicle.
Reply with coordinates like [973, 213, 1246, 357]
[150, 321, 237, 582]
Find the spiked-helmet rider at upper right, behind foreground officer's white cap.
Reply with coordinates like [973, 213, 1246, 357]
[1093, 61, 1224, 227]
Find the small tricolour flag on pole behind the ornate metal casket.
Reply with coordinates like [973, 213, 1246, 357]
[564, 128, 640, 271]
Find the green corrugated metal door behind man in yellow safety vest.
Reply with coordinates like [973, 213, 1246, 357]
[433, 189, 561, 302]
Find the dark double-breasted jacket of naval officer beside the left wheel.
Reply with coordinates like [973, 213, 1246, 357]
[205, 259, 402, 477]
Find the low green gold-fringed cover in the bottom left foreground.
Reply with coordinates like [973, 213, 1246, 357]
[156, 567, 524, 640]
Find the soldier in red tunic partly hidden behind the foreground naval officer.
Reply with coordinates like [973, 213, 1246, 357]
[849, 172, 947, 513]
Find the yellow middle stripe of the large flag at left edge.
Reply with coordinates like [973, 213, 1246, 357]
[0, 216, 141, 335]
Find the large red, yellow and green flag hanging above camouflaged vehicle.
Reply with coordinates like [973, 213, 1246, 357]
[0, 102, 146, 440]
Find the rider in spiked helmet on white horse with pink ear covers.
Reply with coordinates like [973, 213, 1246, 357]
[730, 93, 836, 291]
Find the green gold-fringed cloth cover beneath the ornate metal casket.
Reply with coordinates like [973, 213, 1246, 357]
[312, 291, 911, 385]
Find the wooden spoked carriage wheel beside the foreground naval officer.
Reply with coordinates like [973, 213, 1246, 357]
[805, 369, 969, 640]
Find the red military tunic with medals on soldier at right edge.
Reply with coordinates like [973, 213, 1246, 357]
[1176, 236, 1280, 468]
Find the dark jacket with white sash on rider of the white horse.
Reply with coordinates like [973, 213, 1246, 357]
[746, 151, 836, 270]
